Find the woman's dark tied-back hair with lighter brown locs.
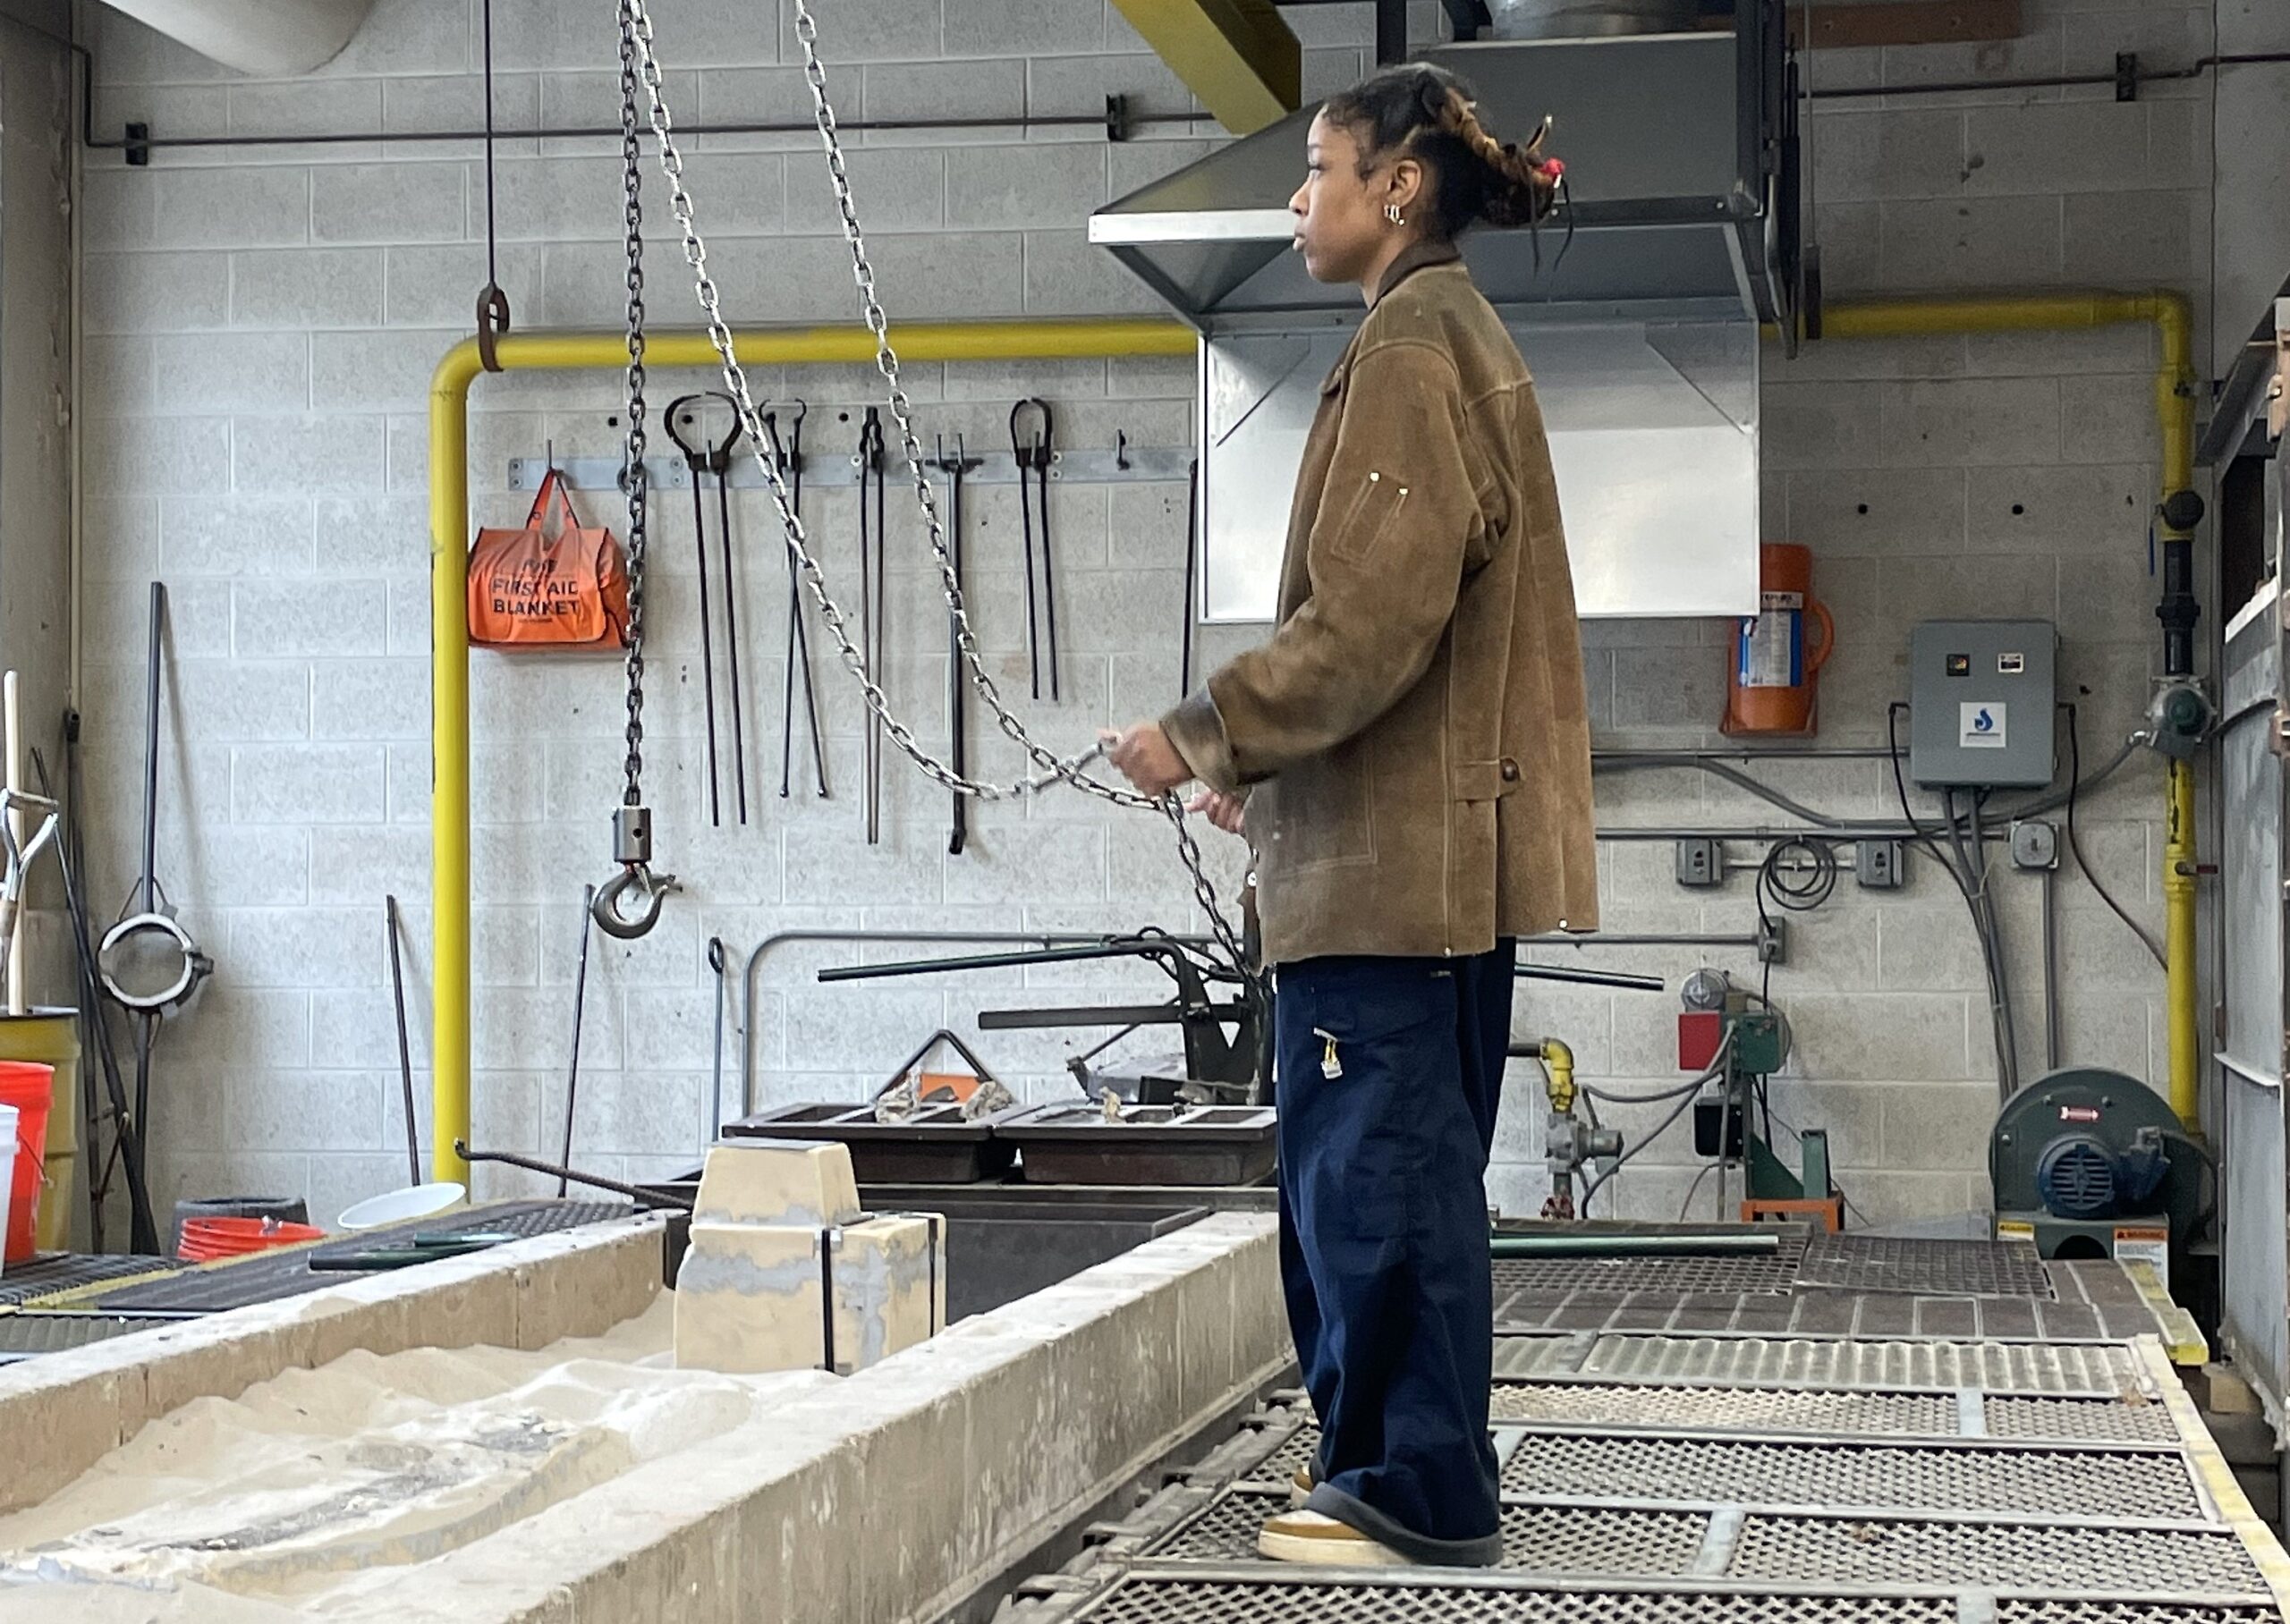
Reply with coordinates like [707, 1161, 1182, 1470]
[1321, 62, 1566, 241]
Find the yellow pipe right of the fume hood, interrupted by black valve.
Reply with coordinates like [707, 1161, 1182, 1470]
[1820, 293, 2201, 1134]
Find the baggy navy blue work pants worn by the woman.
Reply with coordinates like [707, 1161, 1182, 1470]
[1273, 942, 1516, 1564]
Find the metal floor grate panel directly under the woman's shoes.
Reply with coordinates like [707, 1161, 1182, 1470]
[1152, 1493, 1709, 1578]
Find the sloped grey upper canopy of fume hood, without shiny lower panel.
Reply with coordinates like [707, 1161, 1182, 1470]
[1090, 21, 1798, 332]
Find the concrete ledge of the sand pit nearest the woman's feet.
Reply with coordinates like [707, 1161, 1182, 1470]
[318, 1214, 1293, 1624]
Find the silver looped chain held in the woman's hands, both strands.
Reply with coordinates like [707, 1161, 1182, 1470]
[621, 0, 1255, 983]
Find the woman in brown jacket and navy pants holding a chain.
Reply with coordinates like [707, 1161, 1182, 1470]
[1106, 64, 1599, 1567]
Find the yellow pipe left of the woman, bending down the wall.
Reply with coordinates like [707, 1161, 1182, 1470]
[430, 321, 1193, 1180]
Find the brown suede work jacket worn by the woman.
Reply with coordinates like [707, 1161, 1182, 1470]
[1161, 243, 1599, 964]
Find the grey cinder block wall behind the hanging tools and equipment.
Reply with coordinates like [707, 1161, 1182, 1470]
[66, 0, 2242, 1219]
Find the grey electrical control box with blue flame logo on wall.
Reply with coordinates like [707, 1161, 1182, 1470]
[1907, 621, 2058, 791]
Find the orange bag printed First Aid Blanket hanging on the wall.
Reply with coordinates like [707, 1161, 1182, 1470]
[470, 469, 627, 648]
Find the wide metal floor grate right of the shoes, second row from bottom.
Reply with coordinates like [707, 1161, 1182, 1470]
[1726, 1517, 2265, 1596]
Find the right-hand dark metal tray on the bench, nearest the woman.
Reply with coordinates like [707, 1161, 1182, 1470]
[994, 1104, 1276, 1184]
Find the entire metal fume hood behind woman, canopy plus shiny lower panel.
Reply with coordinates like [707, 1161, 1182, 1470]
[1117, 15, 1798, 621]
